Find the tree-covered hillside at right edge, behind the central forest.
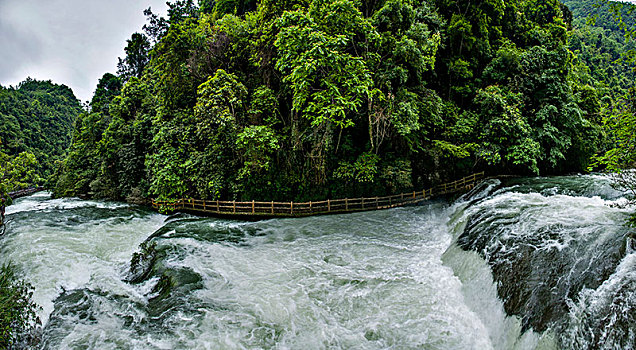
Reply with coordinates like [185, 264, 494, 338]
[565, 0, 636, 200]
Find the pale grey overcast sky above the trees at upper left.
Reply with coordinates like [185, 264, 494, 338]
[0, 0, 166, 101]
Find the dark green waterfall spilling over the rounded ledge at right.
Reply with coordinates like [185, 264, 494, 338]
[456, 176, 636, 349]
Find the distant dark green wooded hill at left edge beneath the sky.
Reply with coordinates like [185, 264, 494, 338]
[0, 79, 81, 185]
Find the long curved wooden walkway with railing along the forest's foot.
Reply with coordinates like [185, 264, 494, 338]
[152, 172, 484, 218]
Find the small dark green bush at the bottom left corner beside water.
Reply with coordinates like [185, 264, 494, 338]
[0, 265, 40, 349]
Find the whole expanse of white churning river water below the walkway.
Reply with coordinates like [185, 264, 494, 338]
[0, 176, 636, 349]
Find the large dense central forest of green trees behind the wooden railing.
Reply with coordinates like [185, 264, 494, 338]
[55, 0, 627, 200]
